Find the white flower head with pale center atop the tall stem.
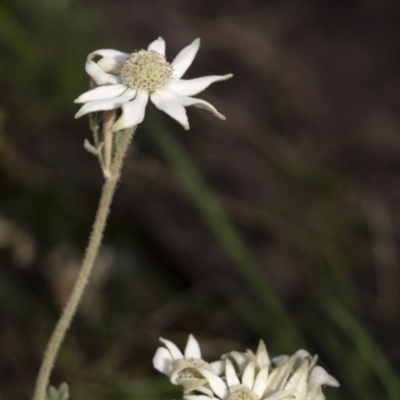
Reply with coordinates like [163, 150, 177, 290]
[75, 38, 233, 131]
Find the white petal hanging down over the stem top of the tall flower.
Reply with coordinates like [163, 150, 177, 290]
[112, 90, 149, 130]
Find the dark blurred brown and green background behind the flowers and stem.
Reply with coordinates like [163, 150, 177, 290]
[0, 0, 400, 400]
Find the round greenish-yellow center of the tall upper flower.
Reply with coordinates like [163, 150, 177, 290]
[121, 50, 174, 94]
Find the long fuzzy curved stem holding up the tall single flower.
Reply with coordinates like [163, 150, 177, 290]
[33, 127, 136, 400]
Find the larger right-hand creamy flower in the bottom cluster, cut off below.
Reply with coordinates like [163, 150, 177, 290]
[185, 341, 339, 400]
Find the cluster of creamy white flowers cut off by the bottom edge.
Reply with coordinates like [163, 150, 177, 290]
[153, 335, 339, 400]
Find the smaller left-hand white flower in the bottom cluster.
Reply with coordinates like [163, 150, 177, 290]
[153, 335, 225, 397]
